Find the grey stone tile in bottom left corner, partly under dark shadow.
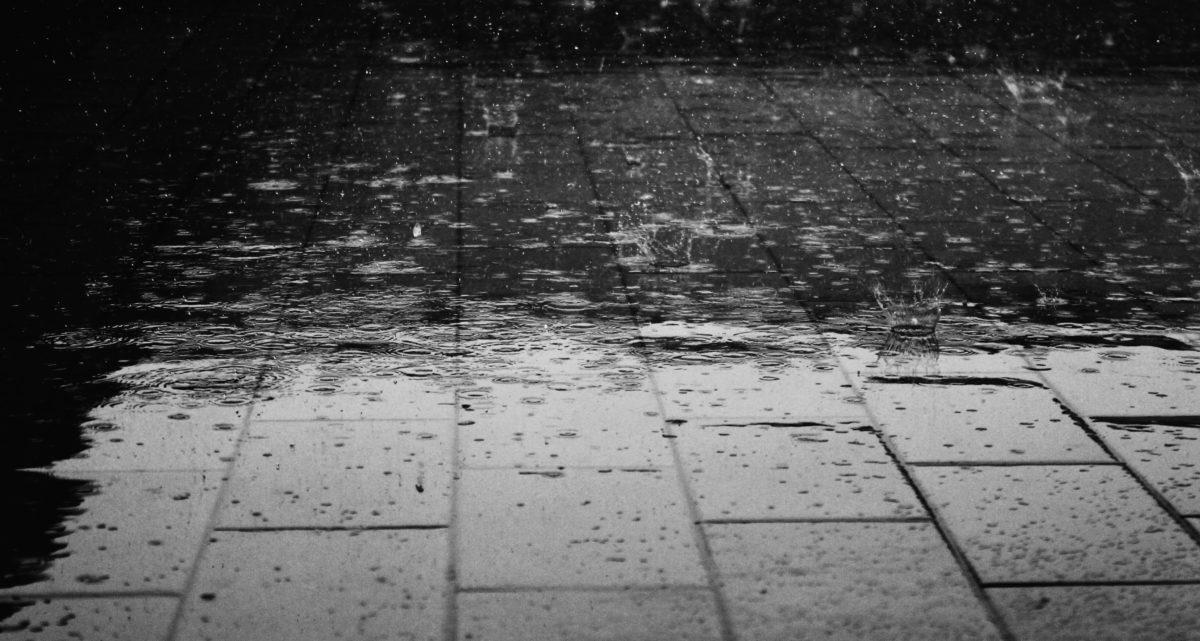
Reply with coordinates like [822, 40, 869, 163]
[0, 597, 179, 641]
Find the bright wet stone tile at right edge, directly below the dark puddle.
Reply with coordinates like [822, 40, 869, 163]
[1033, 347, 1200, 417]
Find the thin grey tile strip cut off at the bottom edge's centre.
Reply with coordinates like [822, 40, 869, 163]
[458, 589, 721, 641]
